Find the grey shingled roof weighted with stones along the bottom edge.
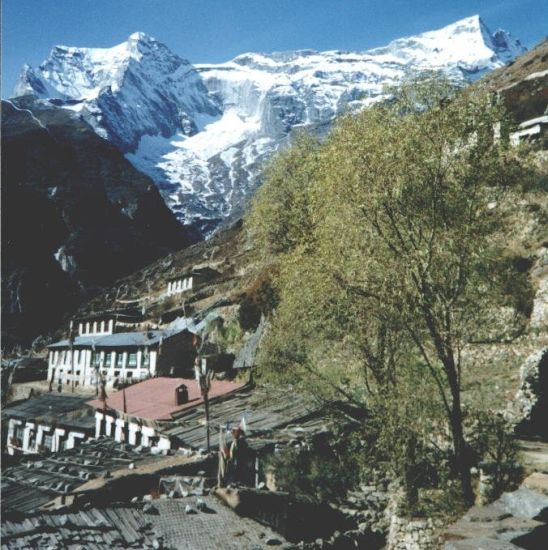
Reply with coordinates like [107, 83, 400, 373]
[2, 496, 284, 550]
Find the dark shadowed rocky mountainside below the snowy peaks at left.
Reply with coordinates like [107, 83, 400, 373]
[2, 97, 199, 347]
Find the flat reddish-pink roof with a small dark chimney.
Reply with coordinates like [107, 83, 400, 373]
[88, 377, 245, 420]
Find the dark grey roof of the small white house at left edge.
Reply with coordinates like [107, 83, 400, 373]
[2, 393, 89, 419]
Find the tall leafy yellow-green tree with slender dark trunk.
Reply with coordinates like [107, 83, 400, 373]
[248, 75, 525, 508]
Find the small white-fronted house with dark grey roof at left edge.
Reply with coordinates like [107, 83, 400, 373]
[2, 394, 95, 455]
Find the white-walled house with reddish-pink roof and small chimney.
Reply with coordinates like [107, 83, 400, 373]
[88, 377, 245, 450]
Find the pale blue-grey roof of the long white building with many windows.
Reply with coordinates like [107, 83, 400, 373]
[48, 326, 197, 349]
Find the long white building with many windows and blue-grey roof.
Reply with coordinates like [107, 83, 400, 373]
[48, 328, 197, 391]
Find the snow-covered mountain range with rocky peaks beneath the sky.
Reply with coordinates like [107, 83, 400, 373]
[15, 16, 525, 233]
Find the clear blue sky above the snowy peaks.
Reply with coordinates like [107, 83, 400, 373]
[2, 0, 548, 97]
